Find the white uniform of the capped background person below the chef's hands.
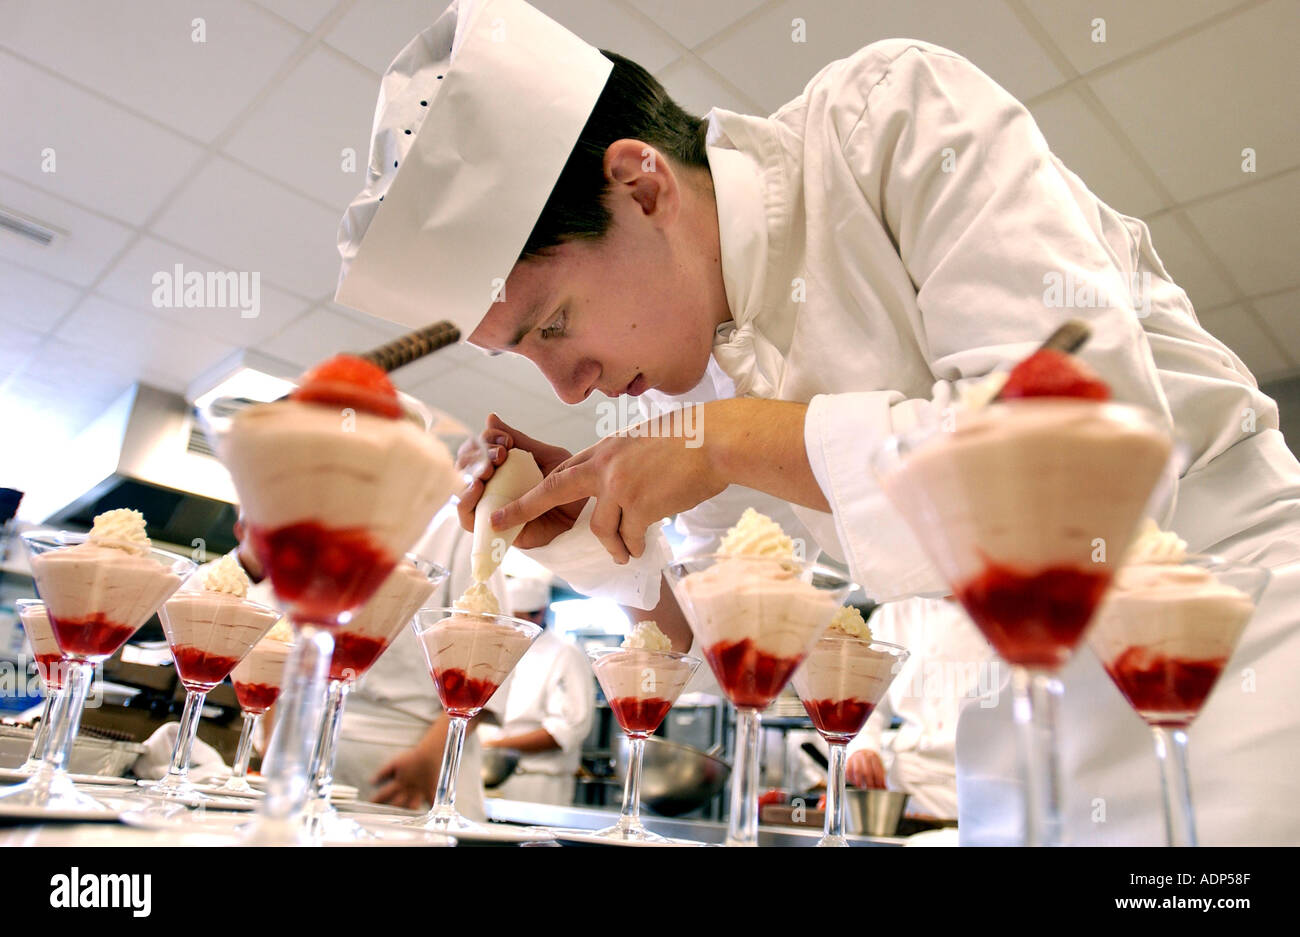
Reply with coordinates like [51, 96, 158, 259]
[497, 630, 595, 806]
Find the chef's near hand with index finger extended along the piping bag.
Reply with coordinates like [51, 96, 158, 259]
[491, 402, 727, 564]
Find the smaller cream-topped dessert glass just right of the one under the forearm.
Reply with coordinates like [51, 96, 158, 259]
[793, 606, 909, 846]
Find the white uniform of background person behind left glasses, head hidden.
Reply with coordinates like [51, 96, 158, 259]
[334, 508, 486, 821]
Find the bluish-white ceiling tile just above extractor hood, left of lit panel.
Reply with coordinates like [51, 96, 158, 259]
[55, 296, 235, 391]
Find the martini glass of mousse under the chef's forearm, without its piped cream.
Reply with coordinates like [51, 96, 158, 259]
[664, 554, 853, 846]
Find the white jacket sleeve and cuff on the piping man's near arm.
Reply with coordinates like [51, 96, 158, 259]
[805, 44, 1173, 600]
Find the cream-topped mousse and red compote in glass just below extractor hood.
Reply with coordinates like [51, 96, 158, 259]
[31, 508, 189, 660]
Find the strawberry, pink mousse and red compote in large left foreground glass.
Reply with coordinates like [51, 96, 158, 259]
[218, 355, 458, 625]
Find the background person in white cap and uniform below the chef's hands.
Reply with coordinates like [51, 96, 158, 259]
[484, 558, 595, 806]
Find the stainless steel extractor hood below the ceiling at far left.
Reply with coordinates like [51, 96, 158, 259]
[38, 383, 235, 554]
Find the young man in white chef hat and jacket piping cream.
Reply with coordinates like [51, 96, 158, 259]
[338, 0, 1300, 843]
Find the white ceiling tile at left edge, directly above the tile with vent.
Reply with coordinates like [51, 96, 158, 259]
[0, 52, 202, 225]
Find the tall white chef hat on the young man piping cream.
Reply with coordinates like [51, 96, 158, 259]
[335, 0, 612, 335]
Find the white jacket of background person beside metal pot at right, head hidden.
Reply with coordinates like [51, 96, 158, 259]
[849, 599, 1010, 817]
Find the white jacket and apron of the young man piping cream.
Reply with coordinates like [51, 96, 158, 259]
[520, 39, 1300, 842]
